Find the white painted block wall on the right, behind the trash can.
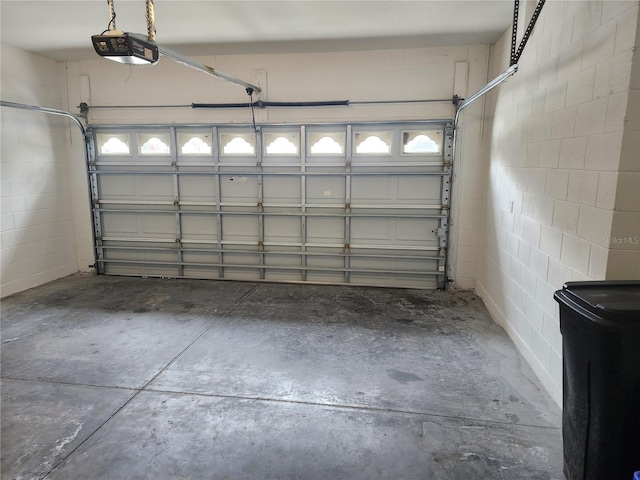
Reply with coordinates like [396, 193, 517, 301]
[477, 1, 640, 402]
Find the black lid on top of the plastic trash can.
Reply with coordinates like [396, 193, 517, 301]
[562, 280, 640, 327]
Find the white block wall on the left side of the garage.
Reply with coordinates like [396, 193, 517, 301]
[0, 45, 85, 296]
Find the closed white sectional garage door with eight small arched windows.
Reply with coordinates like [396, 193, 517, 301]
[89, 121, 452, 288]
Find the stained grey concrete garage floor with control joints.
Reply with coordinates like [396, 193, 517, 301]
[1, 275, 564, 480]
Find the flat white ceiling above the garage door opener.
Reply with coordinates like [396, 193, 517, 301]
[0, 0, 513, 60]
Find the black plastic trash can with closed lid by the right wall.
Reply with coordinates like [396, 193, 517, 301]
[554, 280, 640, 480]
